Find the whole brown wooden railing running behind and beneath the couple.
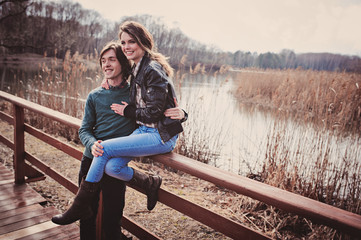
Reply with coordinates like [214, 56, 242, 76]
[0, 91, 361, 239]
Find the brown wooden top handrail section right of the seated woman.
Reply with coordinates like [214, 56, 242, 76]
[151, 153, 361, 236]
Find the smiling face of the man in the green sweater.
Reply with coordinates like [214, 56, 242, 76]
[101, 49, 122, 80]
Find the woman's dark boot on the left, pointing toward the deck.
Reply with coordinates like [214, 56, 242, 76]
[51, 176, 100, 225]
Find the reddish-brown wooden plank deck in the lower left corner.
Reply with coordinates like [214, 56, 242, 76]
[0, 164, 79, 240]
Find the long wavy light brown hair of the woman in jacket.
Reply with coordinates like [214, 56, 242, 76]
[118, 21, 173, 77]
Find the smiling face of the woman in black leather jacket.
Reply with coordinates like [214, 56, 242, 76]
[120, 32, 145, 64]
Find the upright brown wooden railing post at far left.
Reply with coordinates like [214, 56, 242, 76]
[13, 104, 25, 184]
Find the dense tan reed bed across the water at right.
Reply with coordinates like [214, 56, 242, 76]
[234, 69, 361, 134]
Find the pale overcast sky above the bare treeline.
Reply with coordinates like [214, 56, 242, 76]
[63, 0, 361, 56]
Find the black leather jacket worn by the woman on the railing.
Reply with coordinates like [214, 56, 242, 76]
[124, 55, 187, 142]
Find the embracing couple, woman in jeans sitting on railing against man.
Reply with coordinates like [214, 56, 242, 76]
[52, 21, 187, 239]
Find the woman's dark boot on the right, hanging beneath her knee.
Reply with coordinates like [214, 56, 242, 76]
[128, 169, 162, 211]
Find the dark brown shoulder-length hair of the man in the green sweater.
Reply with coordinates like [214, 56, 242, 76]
[99, 41, 131, 80]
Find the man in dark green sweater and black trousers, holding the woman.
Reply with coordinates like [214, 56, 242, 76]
[75, 42, 186, 240]
